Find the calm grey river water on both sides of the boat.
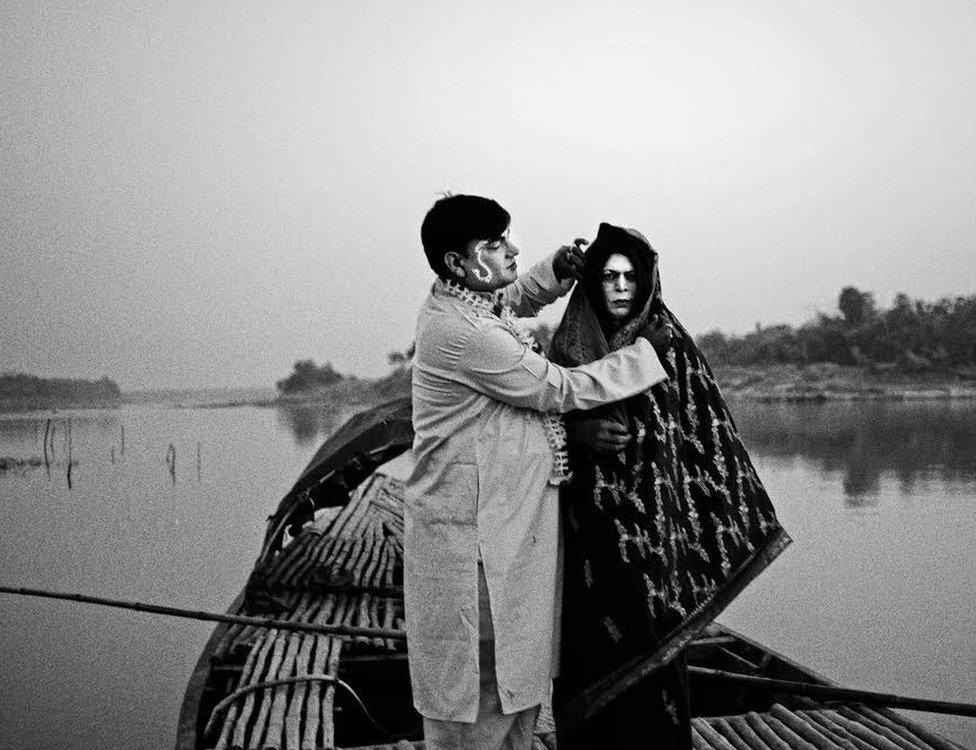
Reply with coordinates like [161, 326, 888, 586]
[0, 402, 976, 750]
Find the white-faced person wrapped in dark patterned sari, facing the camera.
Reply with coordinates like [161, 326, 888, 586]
[549, 223, 790, 750]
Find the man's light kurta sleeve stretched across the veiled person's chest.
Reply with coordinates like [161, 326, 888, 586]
[457, 323, 667, 413]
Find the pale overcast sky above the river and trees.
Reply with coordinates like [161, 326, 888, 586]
[0, 0, 976, 389]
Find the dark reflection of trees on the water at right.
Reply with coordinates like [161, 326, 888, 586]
[731, 401, 976, 507]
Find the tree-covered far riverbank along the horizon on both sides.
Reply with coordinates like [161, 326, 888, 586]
[0, 287, 976, 412]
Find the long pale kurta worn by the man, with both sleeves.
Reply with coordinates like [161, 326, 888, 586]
[404, 258, 666, 722]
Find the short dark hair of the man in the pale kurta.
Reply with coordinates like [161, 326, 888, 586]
[420, 194, 512, 278]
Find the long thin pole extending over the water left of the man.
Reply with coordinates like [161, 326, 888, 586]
[0, 586, 407, 641]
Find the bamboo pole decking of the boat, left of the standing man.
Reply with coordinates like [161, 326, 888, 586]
[208, 476, 403, 750]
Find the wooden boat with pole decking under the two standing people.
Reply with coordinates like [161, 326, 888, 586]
[176, 399, 959, 750]
